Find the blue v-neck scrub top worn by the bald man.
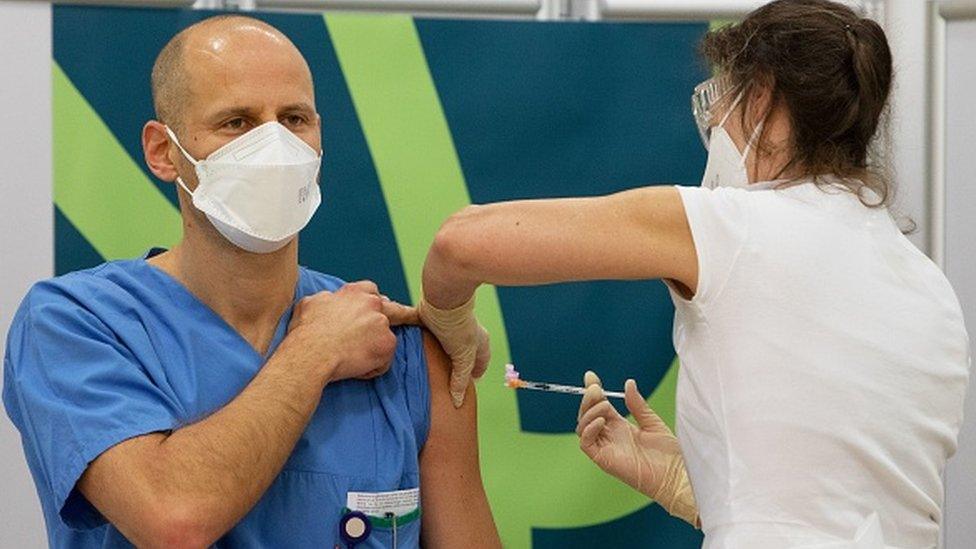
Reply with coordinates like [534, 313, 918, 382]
[3, 250, 430, 549]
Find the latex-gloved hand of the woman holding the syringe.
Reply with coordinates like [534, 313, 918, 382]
[576, 372, 701, 528]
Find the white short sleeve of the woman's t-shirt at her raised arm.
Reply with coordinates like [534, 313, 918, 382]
[677, 186, 751, 305]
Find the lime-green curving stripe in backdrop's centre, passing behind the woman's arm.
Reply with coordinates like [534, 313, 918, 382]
[325, 15, 676, 547]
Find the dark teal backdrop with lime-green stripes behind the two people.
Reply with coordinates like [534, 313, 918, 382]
[52, 6, 708, 548]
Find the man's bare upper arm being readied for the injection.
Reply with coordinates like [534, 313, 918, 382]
[420, 332, 501, 548]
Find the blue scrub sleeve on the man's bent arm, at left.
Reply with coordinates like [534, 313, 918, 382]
[4, 283, 178, 530]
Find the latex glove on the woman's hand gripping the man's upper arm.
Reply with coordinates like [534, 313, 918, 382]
[417, 296, 491, 408]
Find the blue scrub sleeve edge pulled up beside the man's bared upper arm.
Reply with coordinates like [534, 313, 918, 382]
[394, 326, 430, 450]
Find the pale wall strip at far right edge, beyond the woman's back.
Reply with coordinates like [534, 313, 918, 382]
[945, 17, 976, 549]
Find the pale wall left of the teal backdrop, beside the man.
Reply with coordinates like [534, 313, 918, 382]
[0, 1, 54, 549]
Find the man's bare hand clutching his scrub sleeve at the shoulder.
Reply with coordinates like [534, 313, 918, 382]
[283, 281, 397, 383]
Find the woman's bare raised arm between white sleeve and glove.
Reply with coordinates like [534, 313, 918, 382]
[424, 186, 698, 309]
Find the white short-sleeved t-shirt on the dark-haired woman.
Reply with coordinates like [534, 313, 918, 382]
[672, 183, 969, 549]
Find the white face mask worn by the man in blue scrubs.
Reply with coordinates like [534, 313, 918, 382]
[166, 122, 322, 253]
